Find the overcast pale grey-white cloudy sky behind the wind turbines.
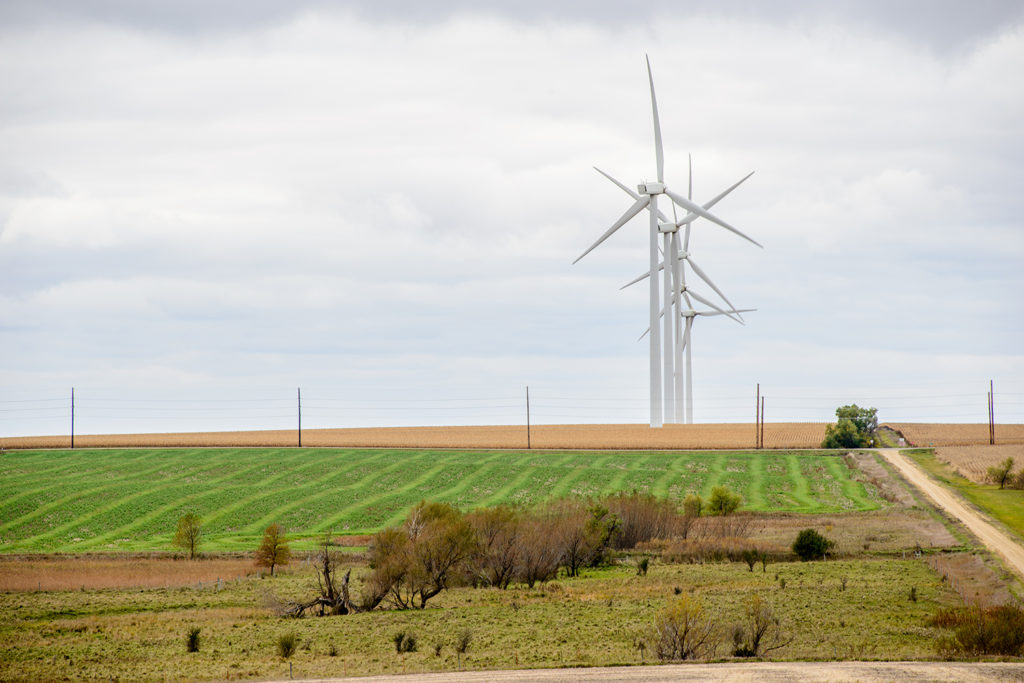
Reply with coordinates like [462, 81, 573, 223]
[0, 0, 1024, 436]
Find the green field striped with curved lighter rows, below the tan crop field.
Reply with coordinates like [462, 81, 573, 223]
[0, 449, 885, 553]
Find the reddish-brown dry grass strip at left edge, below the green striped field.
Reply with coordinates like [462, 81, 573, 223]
[0, 555, 258, 592]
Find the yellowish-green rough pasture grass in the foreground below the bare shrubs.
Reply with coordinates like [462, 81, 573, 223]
[0, 559, 959, 680]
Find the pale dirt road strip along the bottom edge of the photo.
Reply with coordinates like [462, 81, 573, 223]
[303, 661, 1024, 683]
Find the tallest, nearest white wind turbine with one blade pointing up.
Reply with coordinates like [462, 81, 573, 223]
[573, 58, 757, 427]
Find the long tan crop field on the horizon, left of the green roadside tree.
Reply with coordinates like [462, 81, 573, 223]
[0, 422, 825, 450]
